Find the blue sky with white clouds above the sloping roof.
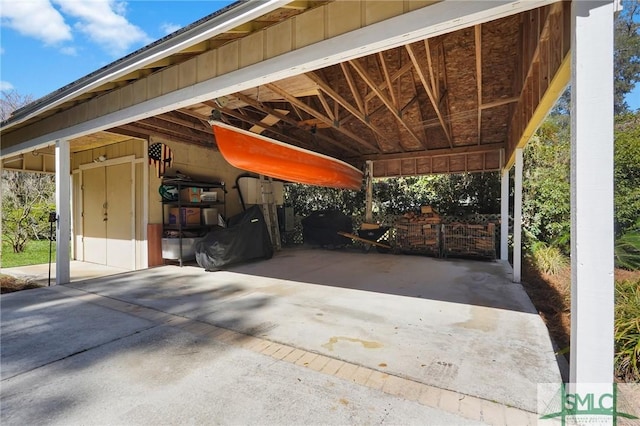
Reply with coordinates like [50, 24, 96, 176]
[0, 0, 640, 110]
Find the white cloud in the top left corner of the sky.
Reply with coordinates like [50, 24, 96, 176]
[0, 0, 72, 45]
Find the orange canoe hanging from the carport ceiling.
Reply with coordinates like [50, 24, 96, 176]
[211, 121, 362, 190]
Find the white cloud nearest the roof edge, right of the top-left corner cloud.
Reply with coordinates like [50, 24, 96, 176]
[53, 0, 152, 56]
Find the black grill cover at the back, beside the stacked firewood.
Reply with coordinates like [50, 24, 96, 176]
[302, 210, 353, 247]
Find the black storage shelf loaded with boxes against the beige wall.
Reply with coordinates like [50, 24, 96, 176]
[160, 179, 227, 266]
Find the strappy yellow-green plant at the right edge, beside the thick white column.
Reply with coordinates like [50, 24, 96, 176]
[614, 279, 640, 382]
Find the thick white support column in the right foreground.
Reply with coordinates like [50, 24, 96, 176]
[570, 1, 614, 388]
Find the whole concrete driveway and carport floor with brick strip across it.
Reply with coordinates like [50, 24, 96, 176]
[0, 249, 561, 424]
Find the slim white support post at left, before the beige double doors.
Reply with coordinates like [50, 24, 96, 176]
[56, 140, 71, 284]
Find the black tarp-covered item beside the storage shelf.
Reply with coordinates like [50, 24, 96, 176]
[195, 205, 273, 270]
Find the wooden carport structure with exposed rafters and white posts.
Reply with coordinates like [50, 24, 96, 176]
[2, 0, 614, 402]
